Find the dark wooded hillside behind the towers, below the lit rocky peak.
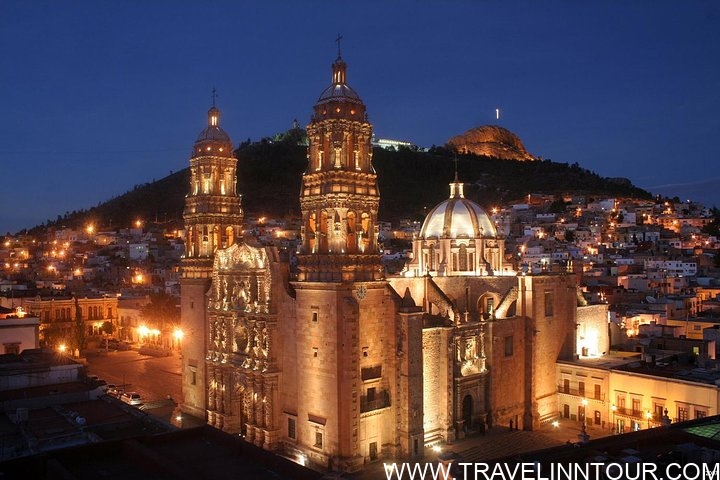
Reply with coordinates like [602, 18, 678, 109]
[32, 139, 651, 232]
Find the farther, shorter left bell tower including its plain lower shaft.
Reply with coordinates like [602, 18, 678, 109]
[180, 98, 243, 418]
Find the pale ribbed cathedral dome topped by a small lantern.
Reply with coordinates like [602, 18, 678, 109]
[420, 179, 498, 239]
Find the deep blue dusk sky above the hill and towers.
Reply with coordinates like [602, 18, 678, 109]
[0, 0, 720, 232]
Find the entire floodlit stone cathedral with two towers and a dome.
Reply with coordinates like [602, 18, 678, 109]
[181, 50, 579, 471]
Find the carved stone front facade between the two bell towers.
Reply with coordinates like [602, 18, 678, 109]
[205, 244, 279, 450]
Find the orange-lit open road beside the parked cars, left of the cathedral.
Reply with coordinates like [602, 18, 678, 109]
[82, 350, 182, 403]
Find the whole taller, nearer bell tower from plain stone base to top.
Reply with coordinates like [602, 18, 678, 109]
[289, 52, 398, 471]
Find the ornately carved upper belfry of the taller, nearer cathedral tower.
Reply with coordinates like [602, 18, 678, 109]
[298, 52, 383, 282]
